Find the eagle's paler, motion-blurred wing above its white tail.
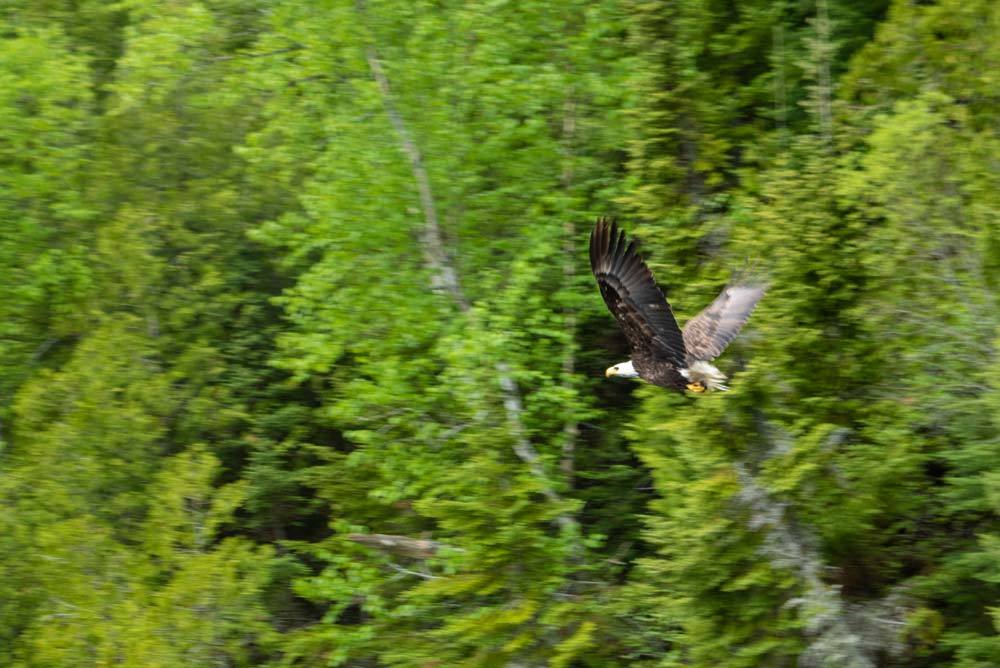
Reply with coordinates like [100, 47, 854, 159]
[684, 283, 766, 365]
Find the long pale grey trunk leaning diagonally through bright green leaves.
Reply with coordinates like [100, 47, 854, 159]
[358, 19, 576, 528]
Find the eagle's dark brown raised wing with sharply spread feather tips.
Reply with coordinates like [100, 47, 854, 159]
[590, 218, 688, 369]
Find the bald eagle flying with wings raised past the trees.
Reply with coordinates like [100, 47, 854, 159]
[590, 218, 765, 392]
